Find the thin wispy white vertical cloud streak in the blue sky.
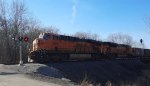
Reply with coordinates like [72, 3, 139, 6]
[71, 0, 78, 24]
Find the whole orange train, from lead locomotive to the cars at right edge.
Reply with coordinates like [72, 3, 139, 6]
[28, 33, 150, 62]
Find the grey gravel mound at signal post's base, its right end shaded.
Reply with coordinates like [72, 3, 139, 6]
[5, 63, 63, 78]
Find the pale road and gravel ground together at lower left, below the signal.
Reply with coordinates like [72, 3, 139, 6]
[0, 64, 78, 86]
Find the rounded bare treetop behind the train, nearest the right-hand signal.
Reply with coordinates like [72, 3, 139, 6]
[107, 33, 134, 46]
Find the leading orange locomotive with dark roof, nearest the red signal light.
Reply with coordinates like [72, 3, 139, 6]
[29, 33, 102, 62]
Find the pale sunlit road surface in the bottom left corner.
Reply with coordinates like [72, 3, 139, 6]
[0, 74, 61, 86]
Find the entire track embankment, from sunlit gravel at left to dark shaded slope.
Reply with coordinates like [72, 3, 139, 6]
[0, 59, 150, 86]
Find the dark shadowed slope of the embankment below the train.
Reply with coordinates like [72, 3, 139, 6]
[47, 59, 150, 85]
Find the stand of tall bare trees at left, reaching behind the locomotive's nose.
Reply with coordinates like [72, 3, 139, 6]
[0, 0, 62, 63]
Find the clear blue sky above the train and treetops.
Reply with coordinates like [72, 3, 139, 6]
[25, 0, 150, 48]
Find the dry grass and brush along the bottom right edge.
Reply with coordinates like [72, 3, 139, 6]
[80, 64, 150, 86]
